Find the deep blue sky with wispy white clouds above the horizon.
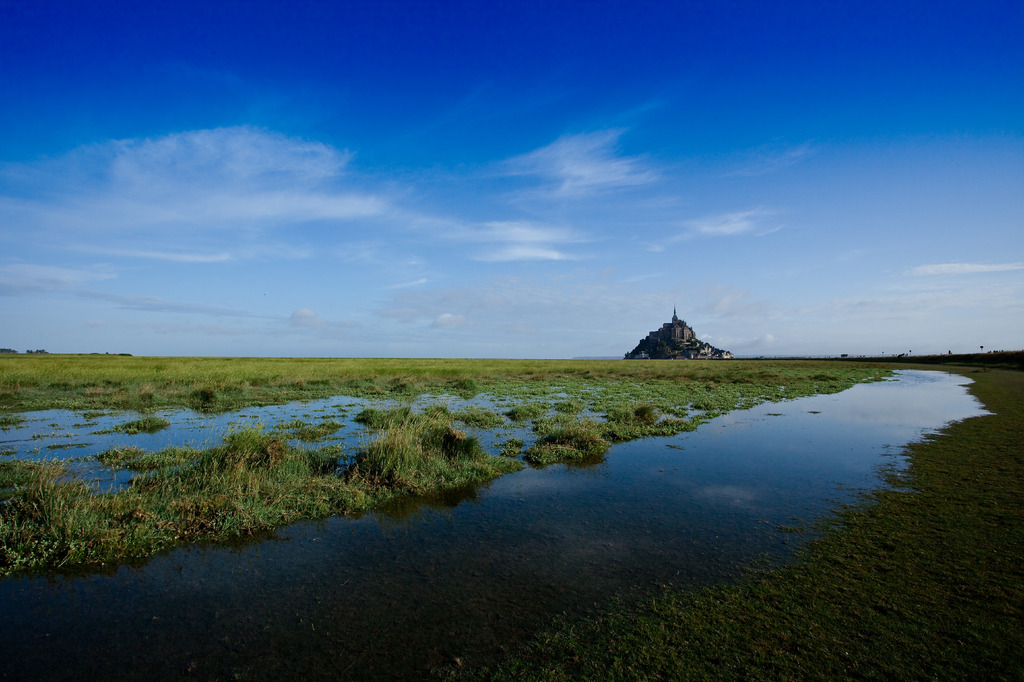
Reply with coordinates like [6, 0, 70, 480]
[0, 0, 1024, 357]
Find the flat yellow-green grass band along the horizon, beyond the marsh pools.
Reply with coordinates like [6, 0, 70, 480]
[0, 353, 888, 411]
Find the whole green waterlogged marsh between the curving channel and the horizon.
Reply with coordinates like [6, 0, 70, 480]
[0, 355, 888, 573]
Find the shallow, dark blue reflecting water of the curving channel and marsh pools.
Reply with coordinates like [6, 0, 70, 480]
[0, 372, 984, 679]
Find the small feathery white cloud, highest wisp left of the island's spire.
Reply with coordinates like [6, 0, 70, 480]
[503, 130, 656, 198]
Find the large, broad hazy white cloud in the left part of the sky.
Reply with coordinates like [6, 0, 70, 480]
[0, 127, 389, 263]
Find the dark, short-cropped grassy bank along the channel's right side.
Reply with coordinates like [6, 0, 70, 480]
[449, 369, 1024, 680]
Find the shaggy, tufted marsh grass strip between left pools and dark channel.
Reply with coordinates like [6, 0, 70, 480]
[0, 409, 522, 573]
